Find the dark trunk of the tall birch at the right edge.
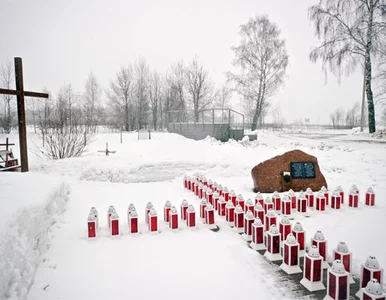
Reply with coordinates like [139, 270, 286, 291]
[365, 0, 376, 133]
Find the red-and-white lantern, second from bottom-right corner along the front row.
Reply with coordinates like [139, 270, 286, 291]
[324, 260, 350, 300]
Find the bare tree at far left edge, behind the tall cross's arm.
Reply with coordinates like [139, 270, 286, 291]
[0, 62, 14, 133]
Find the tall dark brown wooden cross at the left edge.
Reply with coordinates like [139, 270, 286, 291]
[0, 57, 48, 172]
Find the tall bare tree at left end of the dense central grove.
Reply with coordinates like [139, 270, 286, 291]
[106, 64, 134, 131]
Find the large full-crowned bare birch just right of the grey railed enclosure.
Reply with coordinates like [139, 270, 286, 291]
[228, 16, 288, 130]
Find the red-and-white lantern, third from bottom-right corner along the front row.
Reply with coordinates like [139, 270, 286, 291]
[300, 246, 326, 292]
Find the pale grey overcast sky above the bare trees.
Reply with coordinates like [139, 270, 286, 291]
[0, 0, 374, 123]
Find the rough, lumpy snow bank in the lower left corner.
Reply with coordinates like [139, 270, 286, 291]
[0, 183, 70, 299]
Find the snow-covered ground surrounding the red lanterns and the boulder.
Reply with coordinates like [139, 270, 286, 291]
[0, 131, 386, 300]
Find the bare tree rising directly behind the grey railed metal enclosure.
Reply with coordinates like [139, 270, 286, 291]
[185, 57, 213, 122]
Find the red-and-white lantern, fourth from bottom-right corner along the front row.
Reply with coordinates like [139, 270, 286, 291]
[280, 233, 302, 274]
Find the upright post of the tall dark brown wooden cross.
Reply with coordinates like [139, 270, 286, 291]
[15, 57, 28, 172]
